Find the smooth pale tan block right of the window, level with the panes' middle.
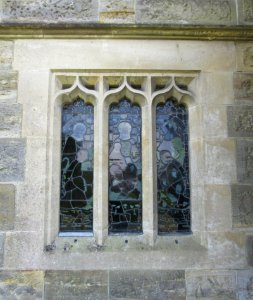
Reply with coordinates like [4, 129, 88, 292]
[205, 139, 236, 184]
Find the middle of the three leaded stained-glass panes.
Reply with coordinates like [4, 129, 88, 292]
[109, 100, 142, 233]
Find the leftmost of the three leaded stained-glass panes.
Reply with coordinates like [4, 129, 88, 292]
[60, 98, 94, 232]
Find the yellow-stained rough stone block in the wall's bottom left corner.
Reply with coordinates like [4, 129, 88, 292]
[0, 271, 44, 300]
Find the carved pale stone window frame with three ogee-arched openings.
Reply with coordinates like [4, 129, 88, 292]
[46, 70, 201, 246]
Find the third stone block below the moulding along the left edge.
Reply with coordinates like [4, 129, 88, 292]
[0, 103, 22, 138]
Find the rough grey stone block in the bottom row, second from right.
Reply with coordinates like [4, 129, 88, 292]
[186, 270, 236, 300]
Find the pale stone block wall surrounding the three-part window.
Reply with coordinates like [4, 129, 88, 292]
[0, 0, 253, 300]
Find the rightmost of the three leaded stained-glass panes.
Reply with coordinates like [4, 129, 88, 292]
[156, 99, 191, 234]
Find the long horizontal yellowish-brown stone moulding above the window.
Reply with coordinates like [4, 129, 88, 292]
[0, 23, 253, 41]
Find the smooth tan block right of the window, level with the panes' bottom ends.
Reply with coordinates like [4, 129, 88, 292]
[205, 185, 232, 231]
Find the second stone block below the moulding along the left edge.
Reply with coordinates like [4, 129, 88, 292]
[0, 71, 18, 104]
